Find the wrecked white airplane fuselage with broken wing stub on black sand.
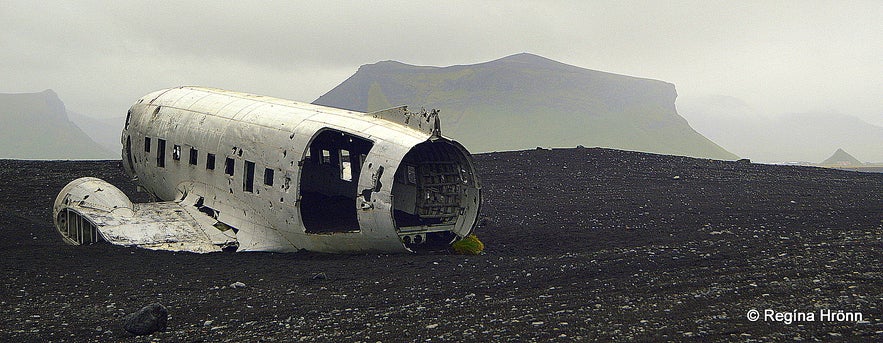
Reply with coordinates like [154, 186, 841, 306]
[53, 87, 481, 253]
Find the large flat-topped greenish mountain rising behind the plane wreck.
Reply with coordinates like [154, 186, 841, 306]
[314, 54, 736, 159]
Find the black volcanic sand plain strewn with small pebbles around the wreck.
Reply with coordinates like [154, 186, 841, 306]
[0, 149, 883, 342]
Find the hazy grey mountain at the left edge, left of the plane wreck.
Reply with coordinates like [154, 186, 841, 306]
[0, 90, 119, 159]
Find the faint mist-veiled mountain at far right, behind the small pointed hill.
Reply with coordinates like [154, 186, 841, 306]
[678, 96, 883, 162]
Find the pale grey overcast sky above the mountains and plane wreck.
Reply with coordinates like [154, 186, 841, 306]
[0, 0, 883, 125]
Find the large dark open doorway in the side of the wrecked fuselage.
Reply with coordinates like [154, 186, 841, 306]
[300, 129, 373, 233]
